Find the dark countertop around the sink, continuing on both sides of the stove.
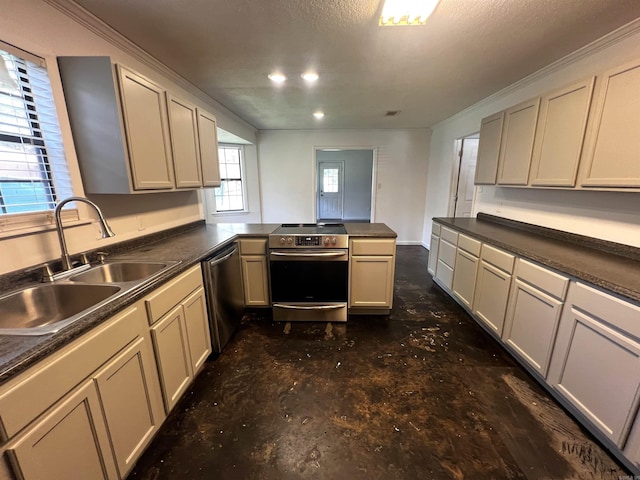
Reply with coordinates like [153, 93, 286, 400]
[0, 222, 396, 384]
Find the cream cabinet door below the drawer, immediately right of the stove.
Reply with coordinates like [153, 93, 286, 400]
[349, 255, 394, 308]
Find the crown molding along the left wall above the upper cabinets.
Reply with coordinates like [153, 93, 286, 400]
[43, 0, 257, 131]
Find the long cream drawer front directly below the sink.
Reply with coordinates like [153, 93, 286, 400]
[0, 304, 148, 440]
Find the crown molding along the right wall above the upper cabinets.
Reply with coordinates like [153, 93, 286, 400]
[431, 18, 640, 129]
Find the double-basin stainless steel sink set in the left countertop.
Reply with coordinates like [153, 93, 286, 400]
[0, 261, 178, 335]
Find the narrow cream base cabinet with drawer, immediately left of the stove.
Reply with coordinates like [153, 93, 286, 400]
[240, 238, 271, 307]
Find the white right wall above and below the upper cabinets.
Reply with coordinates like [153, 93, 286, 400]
[422, 23, 640, 247]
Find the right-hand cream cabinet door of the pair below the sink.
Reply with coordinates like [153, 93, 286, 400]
[94, 337, 165, 478]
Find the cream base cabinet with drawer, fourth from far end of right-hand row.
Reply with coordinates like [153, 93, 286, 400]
[472, 243, 515, 336]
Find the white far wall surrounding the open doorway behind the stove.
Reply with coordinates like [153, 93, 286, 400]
[258, 129, 430, 244]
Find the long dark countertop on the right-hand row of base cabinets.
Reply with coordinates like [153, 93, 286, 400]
[433, 213, 640, 302]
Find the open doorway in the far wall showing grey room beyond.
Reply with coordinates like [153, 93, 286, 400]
[316, 148, 375, 223]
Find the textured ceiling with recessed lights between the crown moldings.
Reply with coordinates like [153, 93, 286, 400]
[70, 0, 640, 129]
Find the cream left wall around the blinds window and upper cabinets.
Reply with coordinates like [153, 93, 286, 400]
[0, 0, 255, 274]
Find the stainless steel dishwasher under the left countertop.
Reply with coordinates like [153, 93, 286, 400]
[202, 242, 244, 353]
